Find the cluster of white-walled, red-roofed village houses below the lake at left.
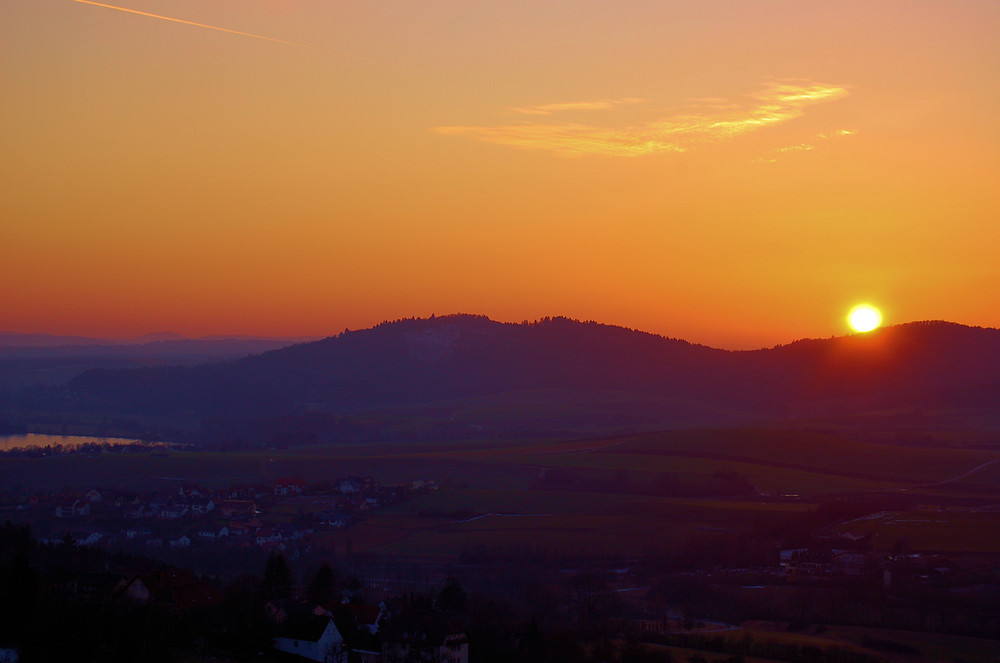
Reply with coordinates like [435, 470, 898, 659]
[13, 476, 437, 556]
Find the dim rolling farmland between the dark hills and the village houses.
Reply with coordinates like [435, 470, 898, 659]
[0, 429, 1000, 560]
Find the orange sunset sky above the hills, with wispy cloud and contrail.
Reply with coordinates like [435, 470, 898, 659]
[0, 0, 1000, 348]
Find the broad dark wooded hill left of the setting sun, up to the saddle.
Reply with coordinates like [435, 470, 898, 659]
[58, 315, 729, 413]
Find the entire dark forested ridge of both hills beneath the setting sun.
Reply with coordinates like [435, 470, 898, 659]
[13, 315, 1000, 438]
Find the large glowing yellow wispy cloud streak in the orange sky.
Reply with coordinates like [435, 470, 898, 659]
[433, 82, 847, 157]
